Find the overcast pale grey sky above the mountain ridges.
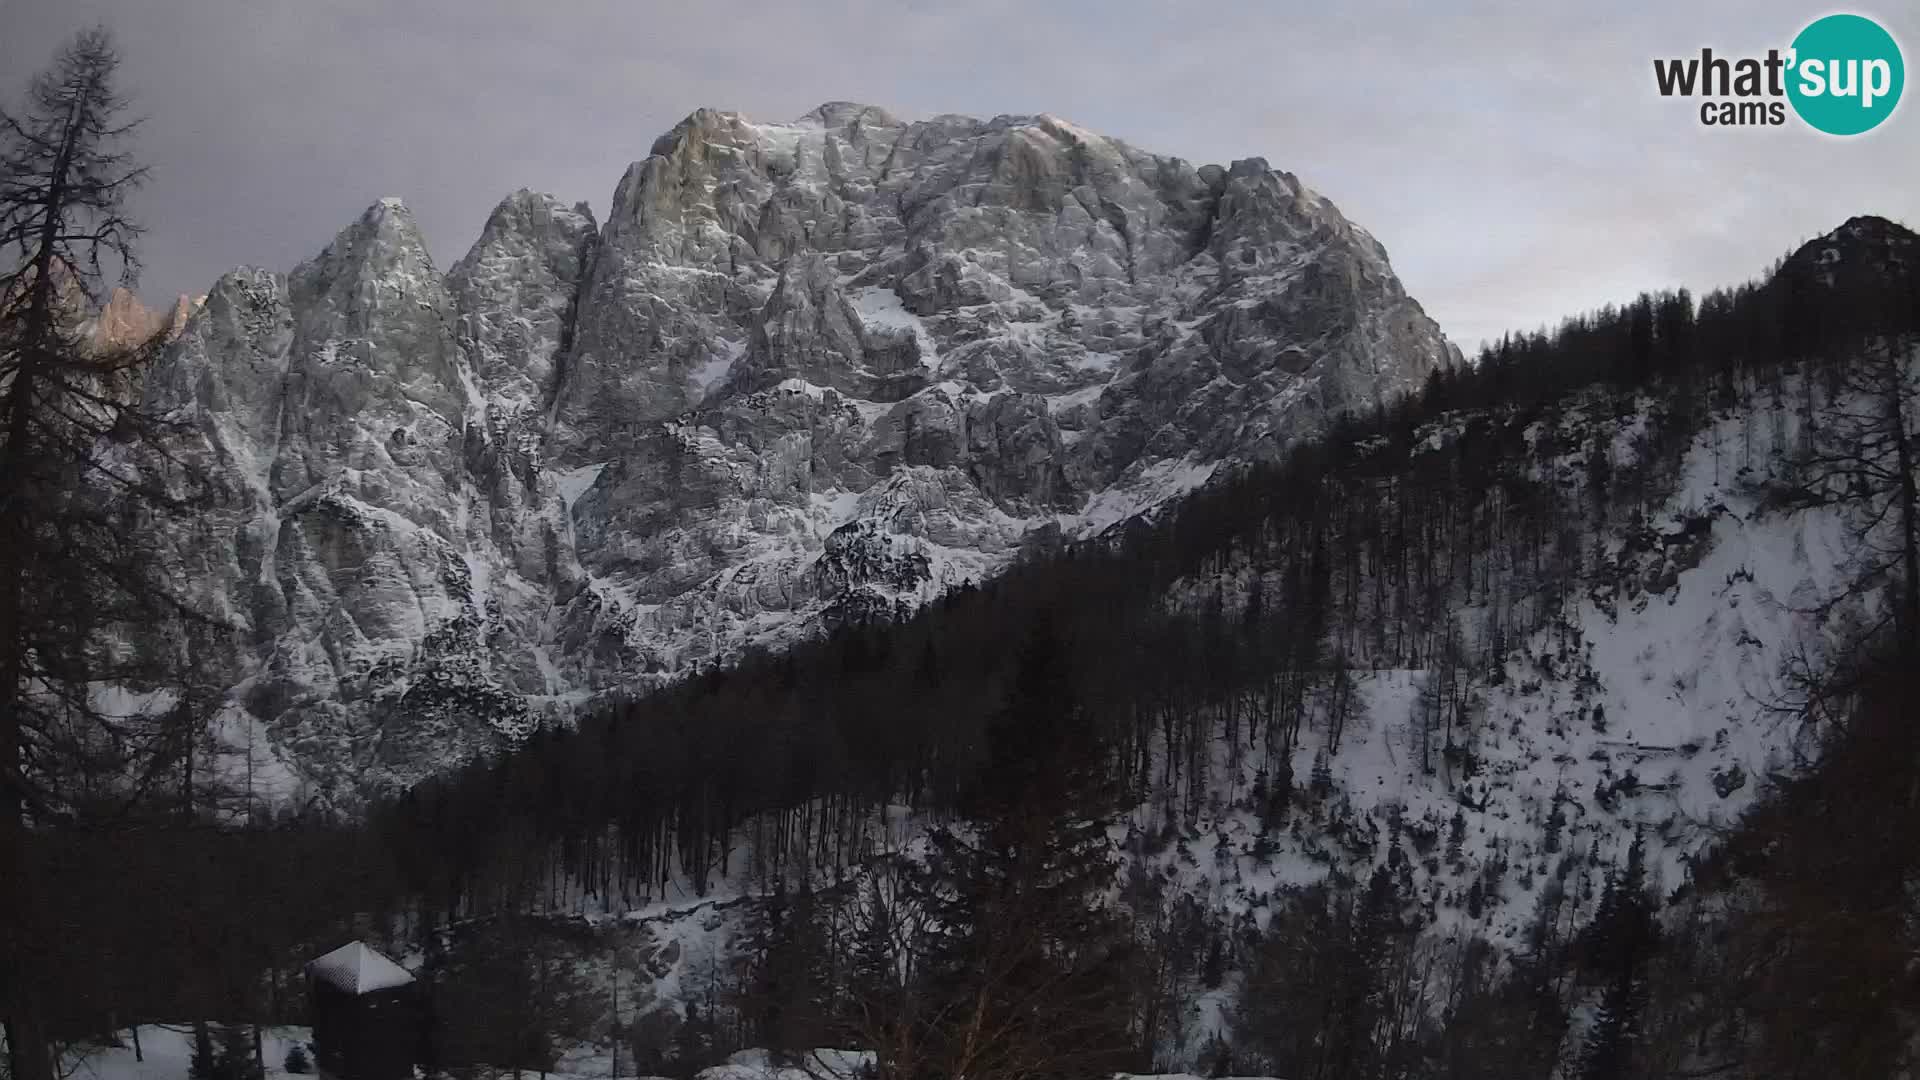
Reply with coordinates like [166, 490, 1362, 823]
[0, 0, 1920, 350]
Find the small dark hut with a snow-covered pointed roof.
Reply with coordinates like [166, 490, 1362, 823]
[307, 942, 426, 1080]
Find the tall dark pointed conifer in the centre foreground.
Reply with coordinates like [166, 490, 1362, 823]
[916, 617, 1131, 1080]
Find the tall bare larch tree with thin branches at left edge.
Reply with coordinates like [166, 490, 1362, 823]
[0, 29, 211, 1080]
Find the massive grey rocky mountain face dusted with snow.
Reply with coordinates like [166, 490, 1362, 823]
[148, 104, 1450, 801]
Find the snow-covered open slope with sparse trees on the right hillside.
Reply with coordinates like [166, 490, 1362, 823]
[1137, 386, 1849, 957]
